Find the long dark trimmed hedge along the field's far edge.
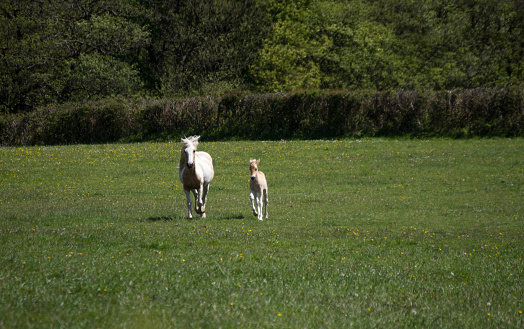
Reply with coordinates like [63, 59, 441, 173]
[0, 86, 524, 146]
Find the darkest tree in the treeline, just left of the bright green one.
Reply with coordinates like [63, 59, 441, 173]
[143, 0, 270, 96]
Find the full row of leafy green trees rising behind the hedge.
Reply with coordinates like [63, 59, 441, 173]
[0, 0, 524, 114]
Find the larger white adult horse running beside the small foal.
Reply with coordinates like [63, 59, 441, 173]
[178, 136, 215, 219]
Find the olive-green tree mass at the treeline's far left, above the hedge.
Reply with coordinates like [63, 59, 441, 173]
[0, 0, 149, 112]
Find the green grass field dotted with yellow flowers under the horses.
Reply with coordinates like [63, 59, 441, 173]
[0, 138, 524, 329]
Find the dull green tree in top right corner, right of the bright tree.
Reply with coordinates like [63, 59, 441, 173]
[372, 0, 524, 89]
